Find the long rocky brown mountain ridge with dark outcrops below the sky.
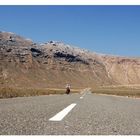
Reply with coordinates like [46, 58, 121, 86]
[0, 32, 140, 88]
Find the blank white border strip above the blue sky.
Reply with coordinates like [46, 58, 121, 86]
[0, 0, 140, 5]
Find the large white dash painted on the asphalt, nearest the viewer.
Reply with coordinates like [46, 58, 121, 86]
[49, 103, 76, 121]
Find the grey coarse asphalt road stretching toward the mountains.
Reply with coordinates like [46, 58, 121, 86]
[0, 91, 140, 135]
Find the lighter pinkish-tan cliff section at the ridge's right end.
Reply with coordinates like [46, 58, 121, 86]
[103, 56, 140, 85]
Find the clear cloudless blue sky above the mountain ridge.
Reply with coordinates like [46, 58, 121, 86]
[0, 6, 140, 57]
